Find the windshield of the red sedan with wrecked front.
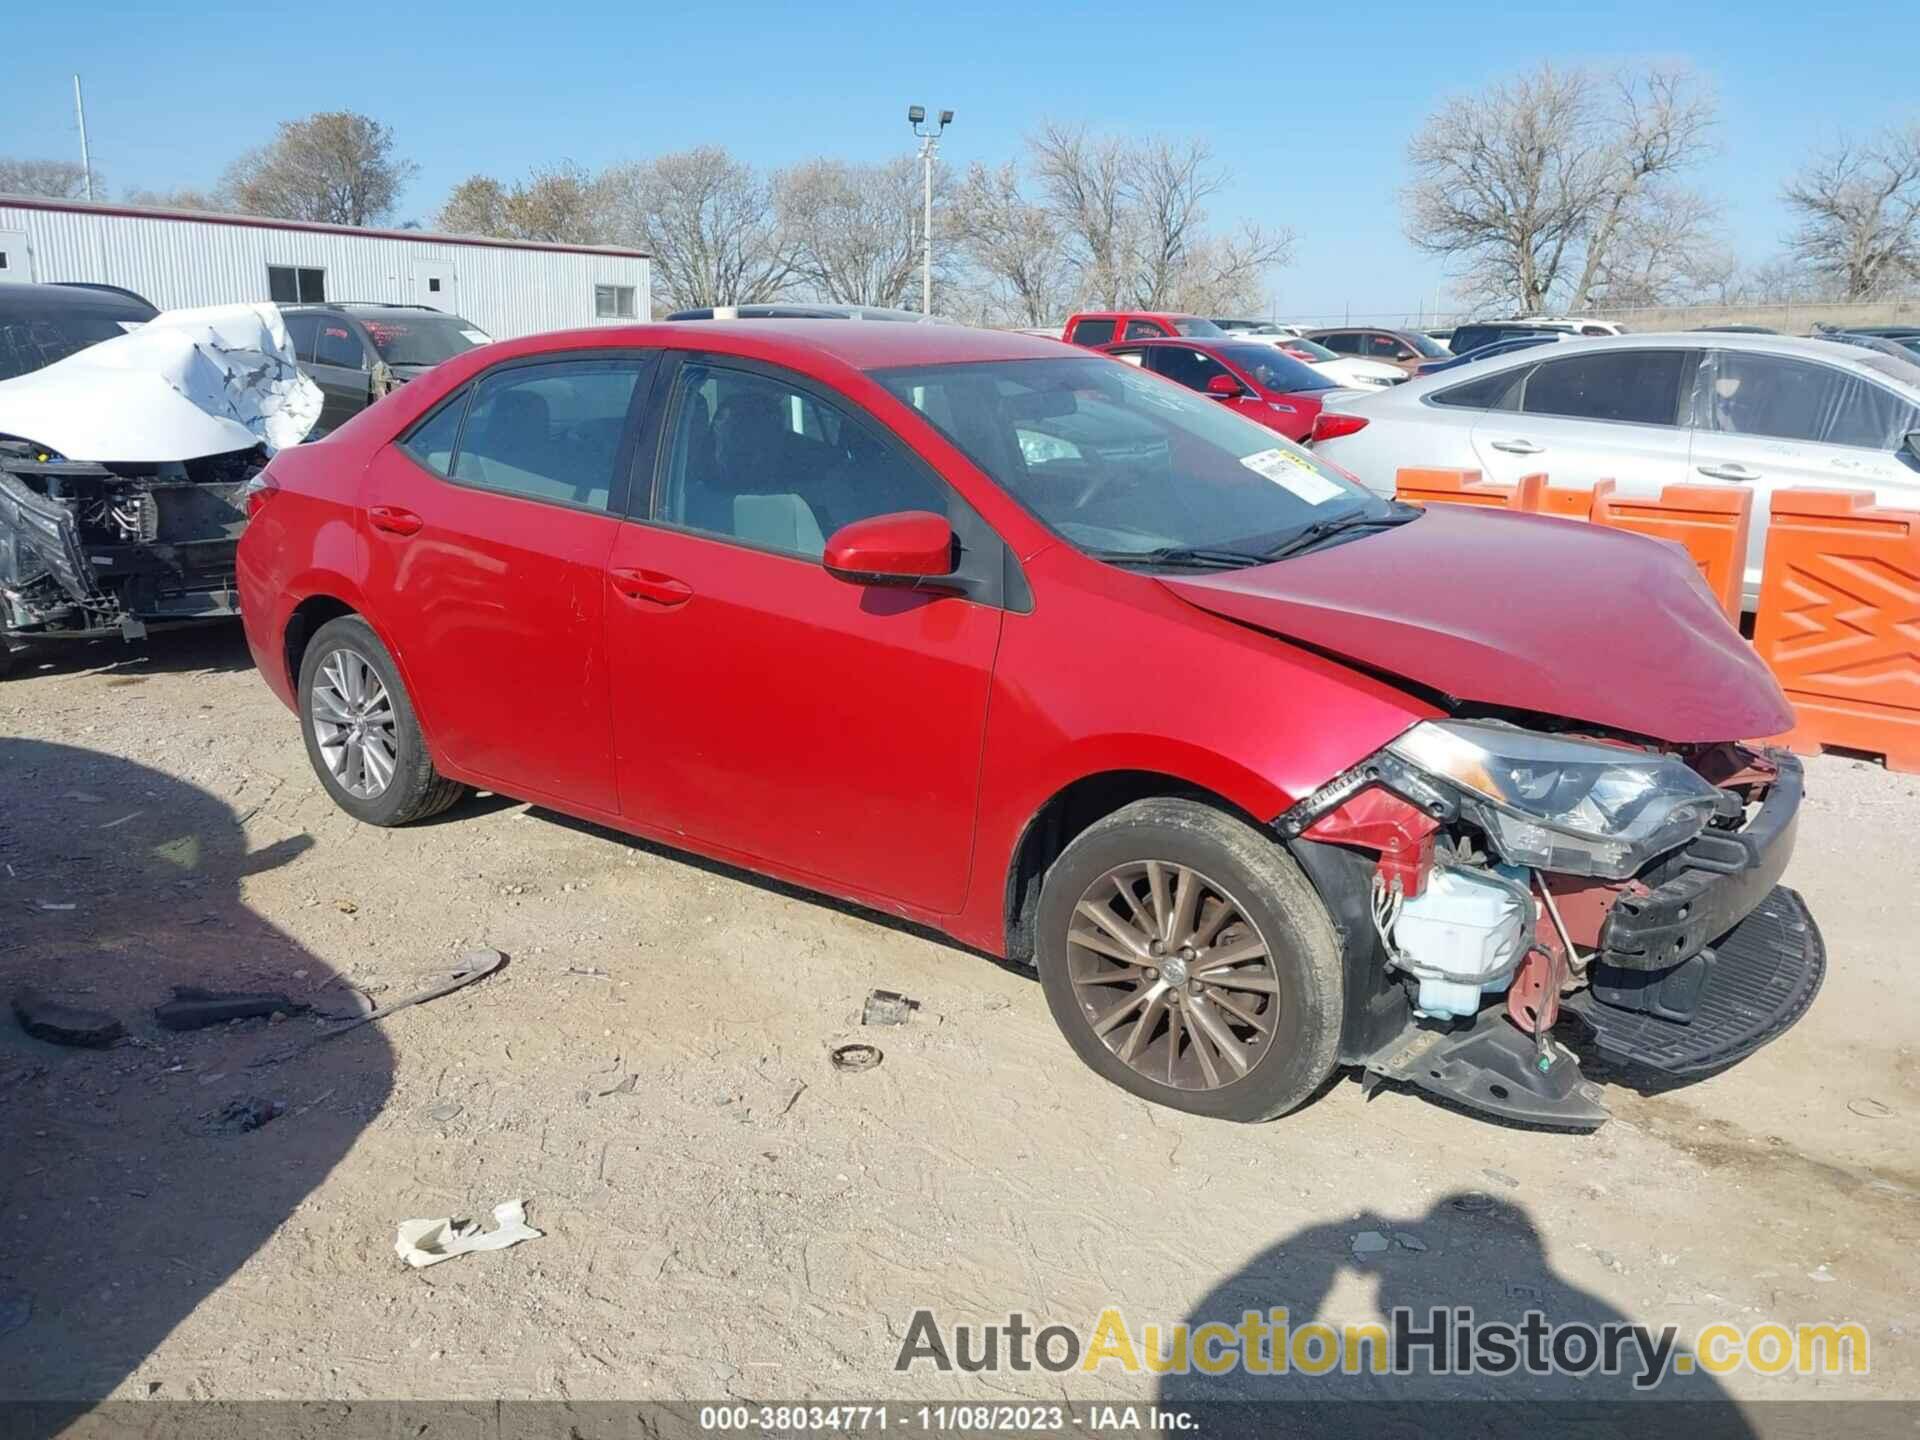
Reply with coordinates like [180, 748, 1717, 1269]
[874, 355, 1386, 563]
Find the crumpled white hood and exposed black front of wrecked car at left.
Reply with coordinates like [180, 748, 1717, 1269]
[0, 305, 321, 674]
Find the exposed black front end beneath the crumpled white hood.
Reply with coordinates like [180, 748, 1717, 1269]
[0, 440, 255, 641]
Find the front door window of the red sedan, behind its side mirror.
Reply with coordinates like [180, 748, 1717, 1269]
[657, 361, 960, 561]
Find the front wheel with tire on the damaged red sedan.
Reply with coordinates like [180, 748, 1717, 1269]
[1035, 799, 1346, 1121]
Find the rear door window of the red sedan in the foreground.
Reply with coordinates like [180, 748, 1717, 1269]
[439, 359, 649, 511]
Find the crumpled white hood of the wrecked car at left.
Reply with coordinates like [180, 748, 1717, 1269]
[0, 305, 321, 465]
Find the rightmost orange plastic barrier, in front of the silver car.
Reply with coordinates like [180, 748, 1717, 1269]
[1753, 490, 1920, 772]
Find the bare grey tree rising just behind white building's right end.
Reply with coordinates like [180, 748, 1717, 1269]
[601, 146, 793, 309]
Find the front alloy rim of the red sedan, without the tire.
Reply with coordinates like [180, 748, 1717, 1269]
[1068, 860, 1281, 1091]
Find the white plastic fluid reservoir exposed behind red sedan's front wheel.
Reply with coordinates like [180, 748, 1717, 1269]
[1394, 866, 1534, 1016]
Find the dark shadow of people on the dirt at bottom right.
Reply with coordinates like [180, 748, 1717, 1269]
[1160, 1192, 1753, 1440]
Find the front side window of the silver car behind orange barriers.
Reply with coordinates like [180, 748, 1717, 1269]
[1693, 349, 1920, 449]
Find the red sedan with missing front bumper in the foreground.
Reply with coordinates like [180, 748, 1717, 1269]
[238, 321, 1824, 1125]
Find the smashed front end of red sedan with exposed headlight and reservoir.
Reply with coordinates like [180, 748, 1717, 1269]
[1275, 720, 1826, 1129]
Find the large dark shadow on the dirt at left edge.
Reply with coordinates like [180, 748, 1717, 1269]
[0, 744, 394, 1430]
